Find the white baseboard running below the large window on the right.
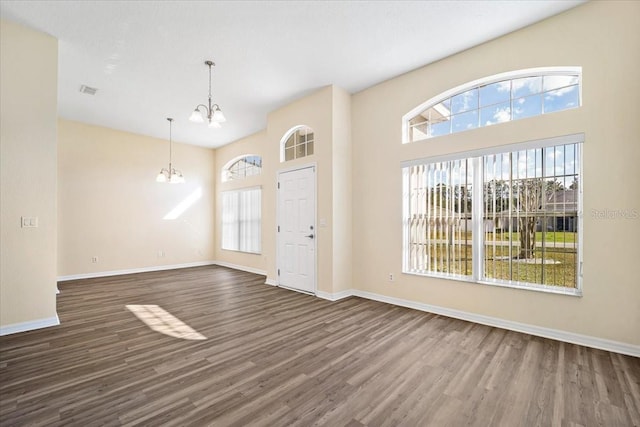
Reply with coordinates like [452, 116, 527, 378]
[318, 289, 640, 357]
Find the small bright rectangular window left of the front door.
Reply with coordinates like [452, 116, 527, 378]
[222, 187, 262, 253]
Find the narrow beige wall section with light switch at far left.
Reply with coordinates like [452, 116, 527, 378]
[0, 21, 58, 331]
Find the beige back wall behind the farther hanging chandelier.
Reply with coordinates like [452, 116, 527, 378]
[58, 118, 215, 276]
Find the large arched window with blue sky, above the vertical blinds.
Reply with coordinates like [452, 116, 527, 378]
[403, 67, 582, 143]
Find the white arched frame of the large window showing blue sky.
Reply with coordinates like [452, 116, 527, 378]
[402, 66, 582, 144]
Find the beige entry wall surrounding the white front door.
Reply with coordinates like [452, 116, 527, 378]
[216, 86, 352, 294]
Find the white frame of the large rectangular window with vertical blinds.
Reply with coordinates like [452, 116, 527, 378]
[401, 133, 585, 296]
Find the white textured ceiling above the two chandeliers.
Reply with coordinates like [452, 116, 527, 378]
[0, 0, 582, 147]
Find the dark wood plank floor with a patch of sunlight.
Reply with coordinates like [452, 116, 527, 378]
[0, 267, 640, 427]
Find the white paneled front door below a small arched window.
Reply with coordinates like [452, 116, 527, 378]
[278, 166, 316, 293]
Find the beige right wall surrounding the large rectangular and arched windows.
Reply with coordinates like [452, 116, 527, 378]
[352, 2, 640, 345]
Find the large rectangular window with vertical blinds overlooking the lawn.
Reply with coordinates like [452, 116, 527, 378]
[403, 135, 583, 293]
